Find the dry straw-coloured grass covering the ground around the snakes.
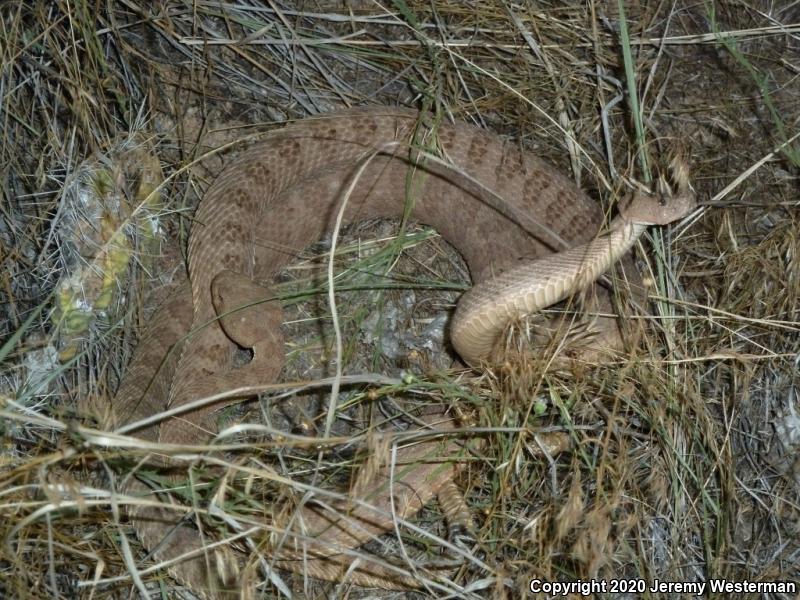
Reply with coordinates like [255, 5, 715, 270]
[0, 0, 800, 599]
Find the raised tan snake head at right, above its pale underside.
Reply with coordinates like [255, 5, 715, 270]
[619, 159, 697, 225]
